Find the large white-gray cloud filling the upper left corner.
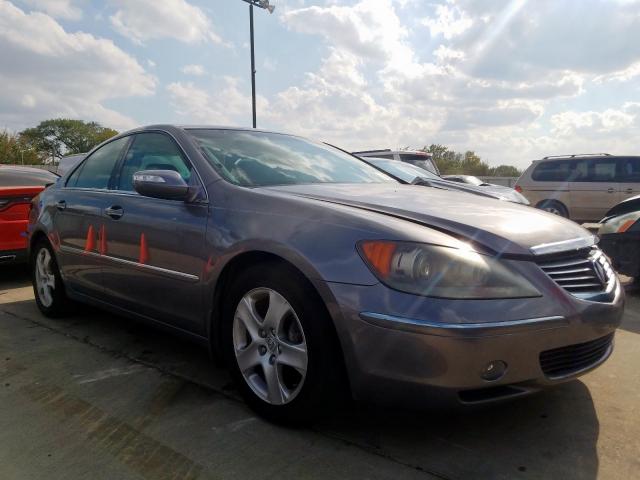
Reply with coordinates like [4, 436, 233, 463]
[0, 0, 156, 128]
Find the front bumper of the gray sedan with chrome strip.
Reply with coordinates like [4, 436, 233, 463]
[330, 276, 624, 406]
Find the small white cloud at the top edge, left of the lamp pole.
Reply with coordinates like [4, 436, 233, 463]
[110, 0, 223, 44]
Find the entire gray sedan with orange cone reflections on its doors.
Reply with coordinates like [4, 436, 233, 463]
[29, 125, 624, 421]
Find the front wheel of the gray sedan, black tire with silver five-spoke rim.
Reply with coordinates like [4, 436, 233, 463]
[222, 263, 344, 424]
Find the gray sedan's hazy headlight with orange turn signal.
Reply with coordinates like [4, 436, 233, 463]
[358, 240, 540, 299]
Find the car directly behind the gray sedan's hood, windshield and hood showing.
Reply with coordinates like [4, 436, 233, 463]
[363, 157, 528, 205]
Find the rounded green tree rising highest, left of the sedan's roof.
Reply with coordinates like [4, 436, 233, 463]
[20, 118, 118, 161]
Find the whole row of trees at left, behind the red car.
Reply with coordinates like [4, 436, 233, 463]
[0, 118, 118, 165]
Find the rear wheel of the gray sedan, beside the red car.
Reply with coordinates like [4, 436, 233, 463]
[31, 239, 72, 317]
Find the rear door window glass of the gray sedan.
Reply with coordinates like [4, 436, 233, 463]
[67, 137, 129, 189]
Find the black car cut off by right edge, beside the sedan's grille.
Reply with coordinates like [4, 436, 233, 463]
[598, 195, 640, 280]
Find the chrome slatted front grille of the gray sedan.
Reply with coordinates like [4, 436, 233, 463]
[538, 248, 615, 296]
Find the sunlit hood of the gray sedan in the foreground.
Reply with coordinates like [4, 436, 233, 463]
[264, 184, 592, 256]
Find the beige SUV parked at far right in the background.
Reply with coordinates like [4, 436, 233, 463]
[515, 153, 640, 222]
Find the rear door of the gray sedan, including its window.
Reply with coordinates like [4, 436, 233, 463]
[51, 137, 129, 297]
